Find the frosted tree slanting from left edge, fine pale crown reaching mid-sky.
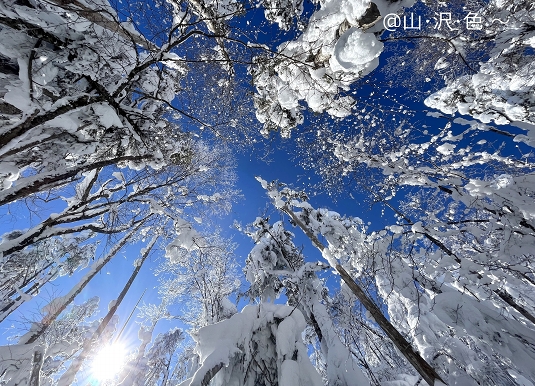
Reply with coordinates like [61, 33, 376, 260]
[0, 139, 237, 338]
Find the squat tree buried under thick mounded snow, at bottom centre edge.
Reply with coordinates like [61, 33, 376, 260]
[183, 303, 323, 386]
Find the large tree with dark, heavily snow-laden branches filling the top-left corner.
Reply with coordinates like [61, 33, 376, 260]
[0, 1, 253, 204]
